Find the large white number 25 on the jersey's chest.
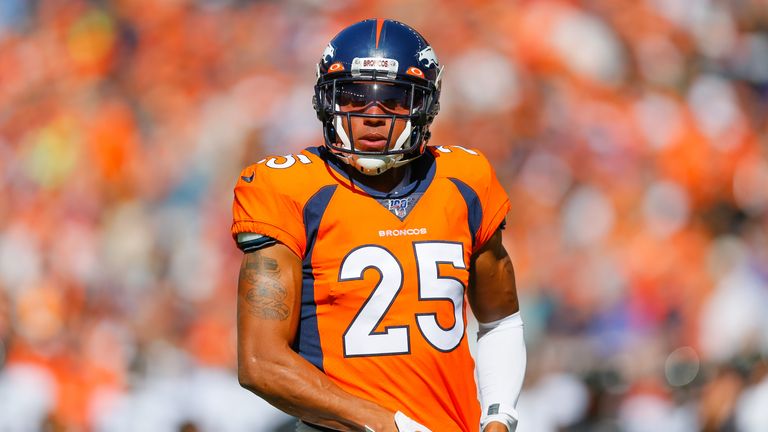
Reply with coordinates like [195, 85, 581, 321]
[339, 242, 466, 357]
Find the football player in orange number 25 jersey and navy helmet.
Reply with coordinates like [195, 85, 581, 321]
[232, 19, 526, 432]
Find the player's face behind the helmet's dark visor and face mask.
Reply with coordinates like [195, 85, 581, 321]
[337, 82, 420, 152]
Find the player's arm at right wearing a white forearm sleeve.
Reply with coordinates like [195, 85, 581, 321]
[468, 229, 526, 432]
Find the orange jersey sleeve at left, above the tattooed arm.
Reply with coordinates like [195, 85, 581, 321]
[232, 164, 306, 257]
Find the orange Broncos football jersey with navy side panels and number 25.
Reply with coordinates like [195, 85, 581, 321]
[232, 146, 510, 432]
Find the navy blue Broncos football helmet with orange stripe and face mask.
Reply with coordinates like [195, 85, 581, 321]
[313, 19, 443, 175]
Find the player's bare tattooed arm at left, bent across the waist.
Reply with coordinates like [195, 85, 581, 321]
[237, 243, 397, 432]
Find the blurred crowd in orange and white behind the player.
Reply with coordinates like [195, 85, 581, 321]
[0, 0, 768, 432]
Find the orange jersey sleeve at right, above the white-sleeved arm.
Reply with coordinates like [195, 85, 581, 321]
[475, 156, 511, 250]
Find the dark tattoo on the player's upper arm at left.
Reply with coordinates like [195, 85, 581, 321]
[240, 252, 290, 321]
